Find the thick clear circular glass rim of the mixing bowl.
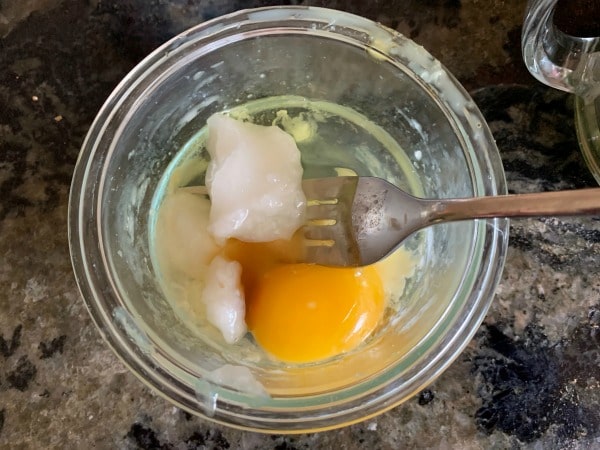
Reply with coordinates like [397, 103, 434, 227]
[68, 6, 508, 433]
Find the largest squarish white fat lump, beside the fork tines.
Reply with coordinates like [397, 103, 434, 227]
[206, 114, 306, 242]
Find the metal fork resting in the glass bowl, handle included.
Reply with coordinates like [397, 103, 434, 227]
[302, 177, 600, 267]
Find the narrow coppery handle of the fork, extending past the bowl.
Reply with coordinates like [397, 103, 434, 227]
[427, 188, 600, 223]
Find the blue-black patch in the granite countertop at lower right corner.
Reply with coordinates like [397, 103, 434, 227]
[474, 326, 600, 442]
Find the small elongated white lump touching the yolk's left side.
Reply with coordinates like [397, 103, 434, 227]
[201, 255, 246, 344]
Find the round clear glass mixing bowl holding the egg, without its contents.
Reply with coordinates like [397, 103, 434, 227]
[69, 7, 508, 432]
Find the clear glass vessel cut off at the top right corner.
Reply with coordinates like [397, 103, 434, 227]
[521, 0, 600, 183]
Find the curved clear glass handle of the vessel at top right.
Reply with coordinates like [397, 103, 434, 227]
[521, 0, 600, 98]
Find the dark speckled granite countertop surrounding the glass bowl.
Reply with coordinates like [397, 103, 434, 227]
[0, 0, 600, 449]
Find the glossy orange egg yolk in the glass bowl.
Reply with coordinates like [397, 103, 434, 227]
[227, 241, 385, 363]
